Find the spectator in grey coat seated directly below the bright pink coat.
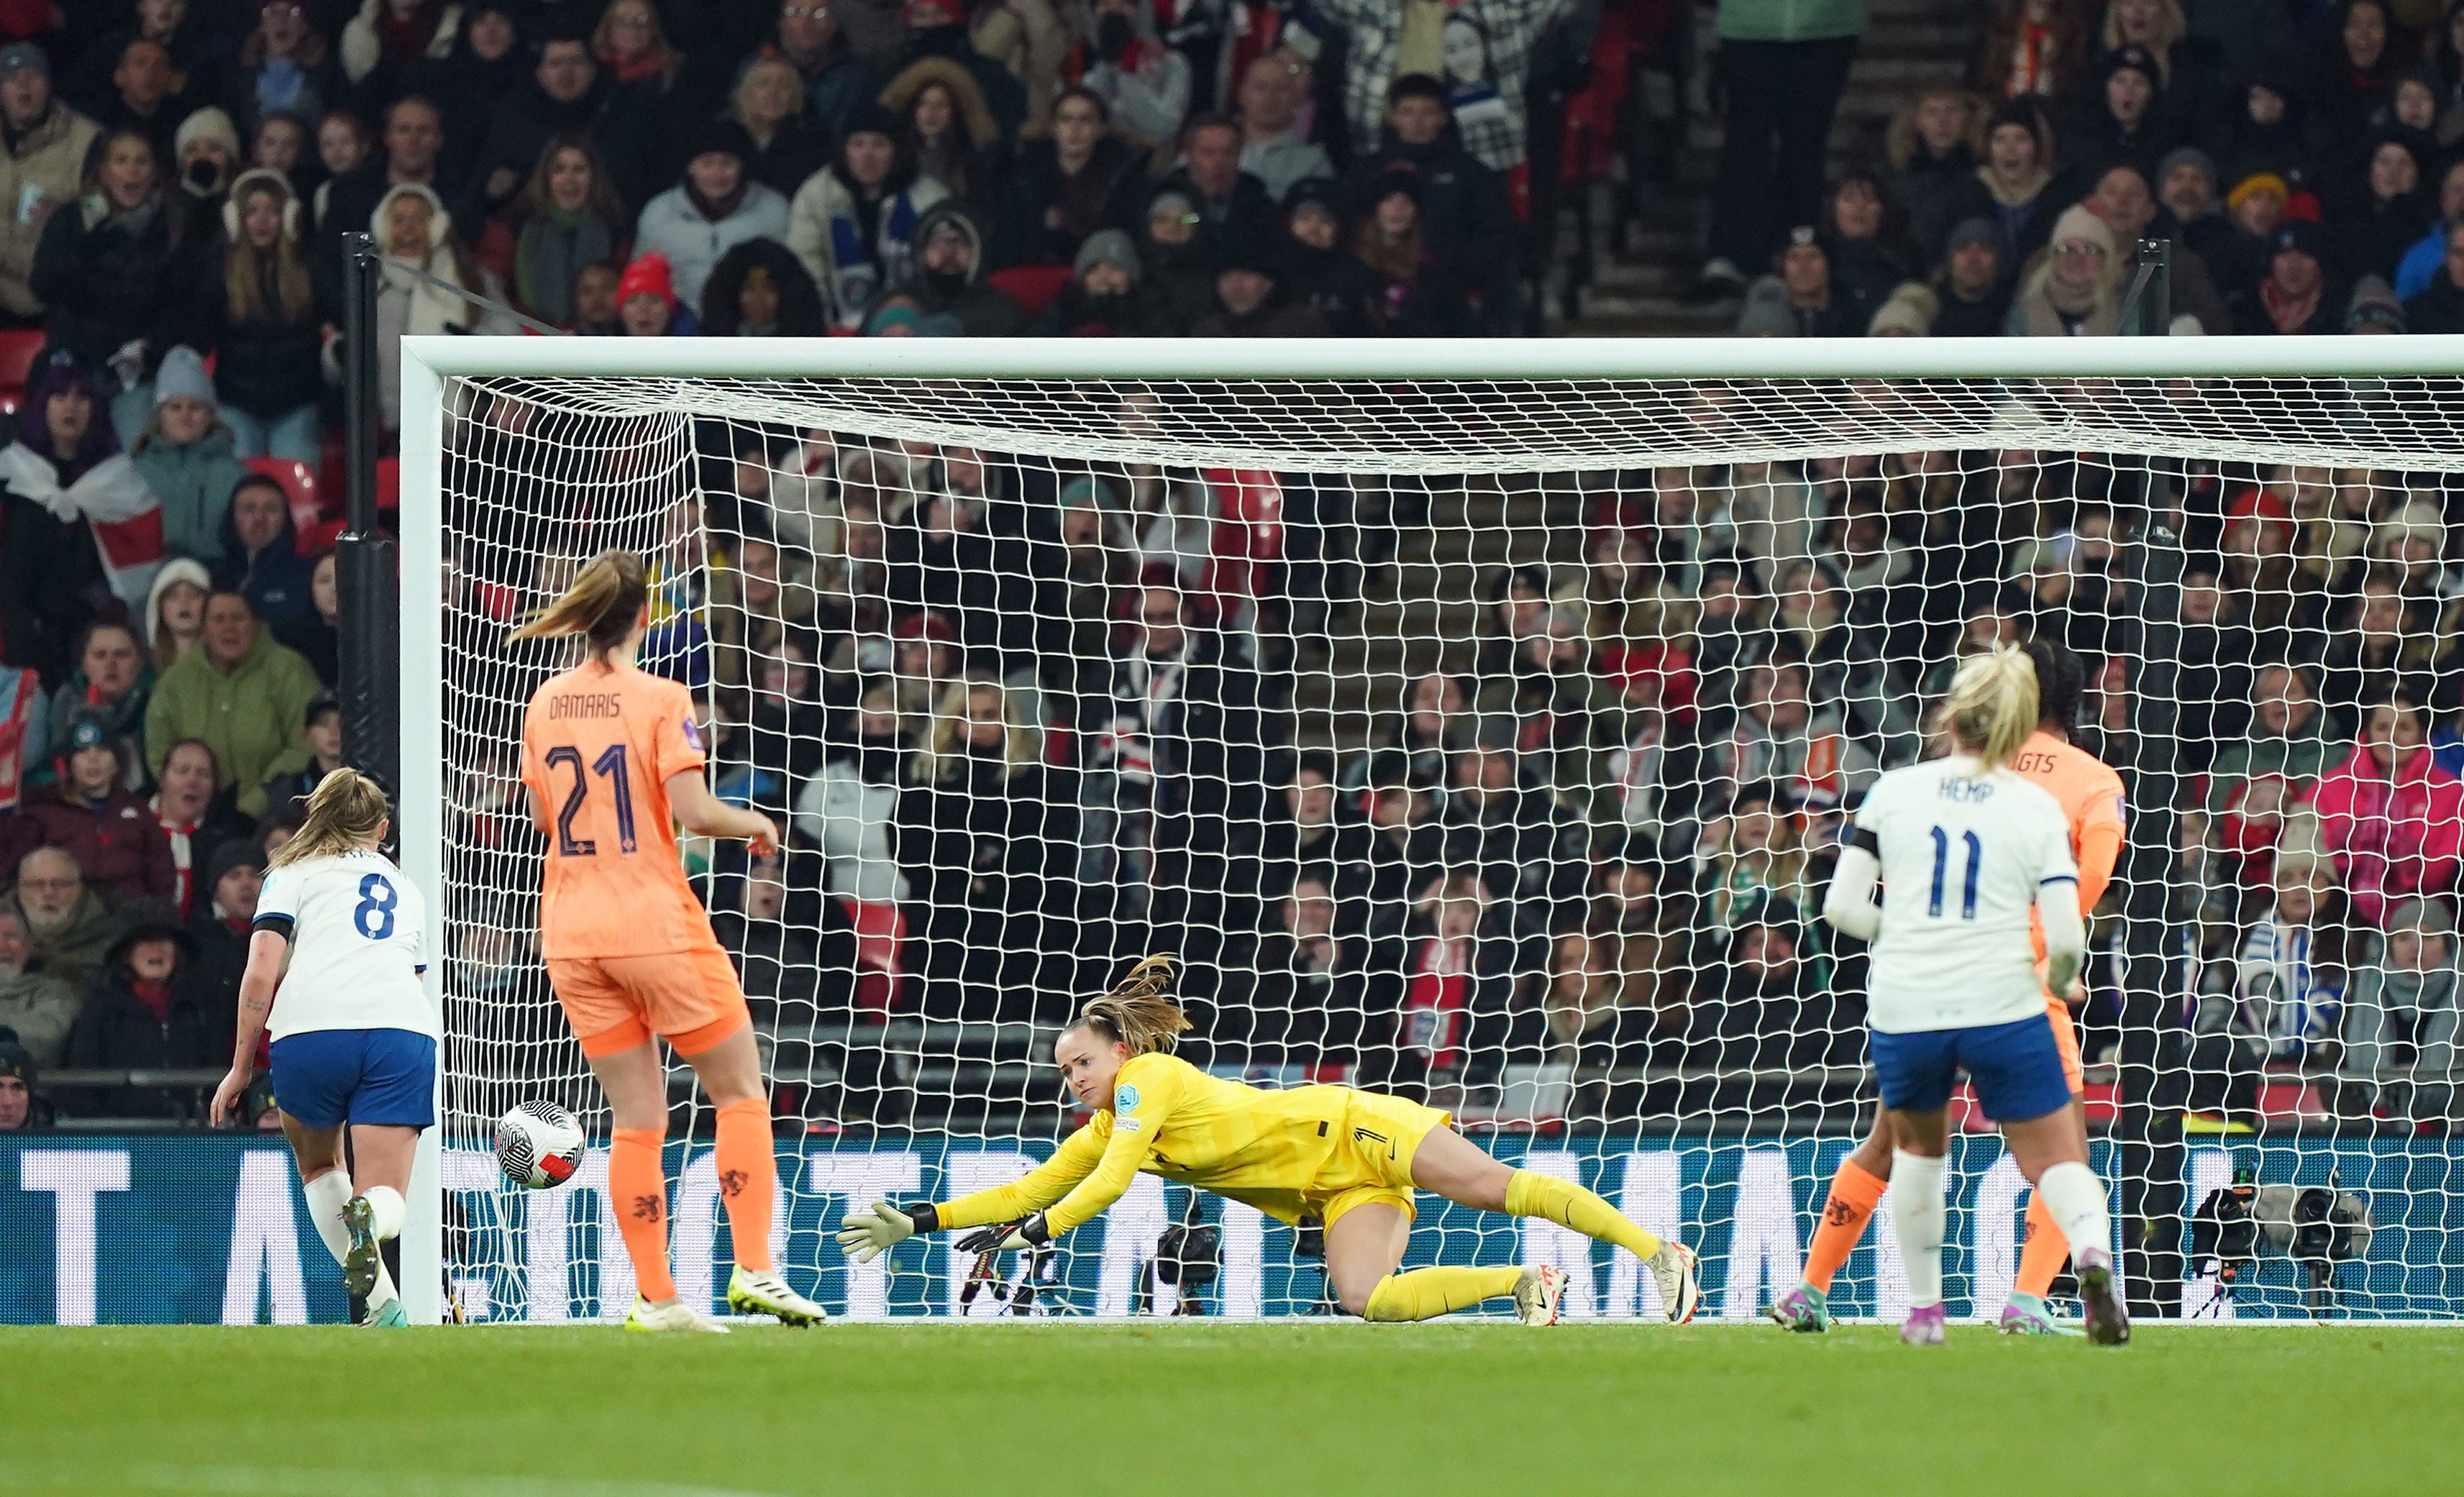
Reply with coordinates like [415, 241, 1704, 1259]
[2336, 899, 2464, 1127]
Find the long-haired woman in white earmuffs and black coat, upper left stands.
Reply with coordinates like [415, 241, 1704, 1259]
[210, 168, 325, 465]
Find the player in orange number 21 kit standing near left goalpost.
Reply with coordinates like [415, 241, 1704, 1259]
[513, 551, 826, 1329]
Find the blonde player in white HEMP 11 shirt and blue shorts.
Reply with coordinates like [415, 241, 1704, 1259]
[1823, 645, 2131, 1347]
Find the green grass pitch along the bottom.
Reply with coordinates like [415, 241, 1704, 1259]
[0, 1322, 2464, 1497]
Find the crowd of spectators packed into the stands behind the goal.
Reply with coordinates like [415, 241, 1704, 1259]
[0, 0, 2464, 1125]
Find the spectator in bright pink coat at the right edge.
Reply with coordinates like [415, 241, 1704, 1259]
[2312, 695, 2464, 928]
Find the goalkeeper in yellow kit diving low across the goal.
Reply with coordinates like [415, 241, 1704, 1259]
[838, 956, 1700, 1324]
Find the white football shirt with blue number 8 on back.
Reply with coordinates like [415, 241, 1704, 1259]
[256, 852, 444, 1039]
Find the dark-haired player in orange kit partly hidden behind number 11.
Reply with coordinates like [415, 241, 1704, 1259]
[1764, 640, 2124, 1335]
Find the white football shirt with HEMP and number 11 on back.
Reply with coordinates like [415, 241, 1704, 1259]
[1856, 754, 2080, 1034]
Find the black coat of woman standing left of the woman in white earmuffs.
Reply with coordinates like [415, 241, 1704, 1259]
[32, 190, 214, 377]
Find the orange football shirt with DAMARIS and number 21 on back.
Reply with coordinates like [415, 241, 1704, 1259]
[522, 660, 719, 960]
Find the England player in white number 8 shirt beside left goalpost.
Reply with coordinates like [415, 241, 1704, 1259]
[212, 768, 439, 1324]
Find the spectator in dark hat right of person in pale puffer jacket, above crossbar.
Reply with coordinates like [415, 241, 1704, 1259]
[786, 104, 949, 330]
